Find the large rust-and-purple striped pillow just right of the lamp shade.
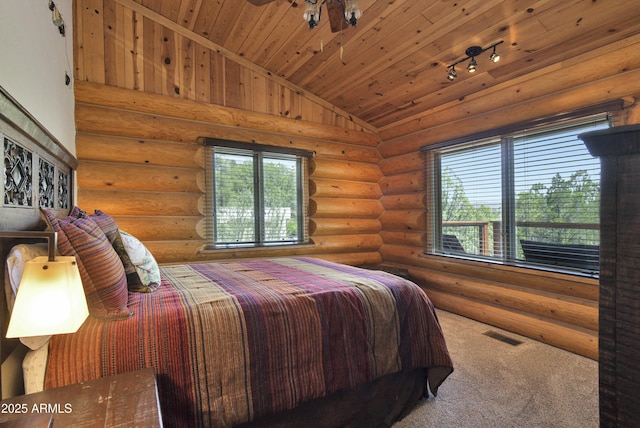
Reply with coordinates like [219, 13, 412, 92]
[40, 207, 132, 319]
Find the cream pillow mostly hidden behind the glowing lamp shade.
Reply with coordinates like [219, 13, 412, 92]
[4, 244, 51, 350]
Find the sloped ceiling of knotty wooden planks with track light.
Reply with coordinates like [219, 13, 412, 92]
[129, 0, 640, 128]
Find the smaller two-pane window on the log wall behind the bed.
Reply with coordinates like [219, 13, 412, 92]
[208, 140, 308, 248]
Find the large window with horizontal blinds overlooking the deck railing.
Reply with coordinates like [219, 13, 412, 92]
[426, 114, 609, 274]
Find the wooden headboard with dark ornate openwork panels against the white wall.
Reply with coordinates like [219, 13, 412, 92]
[0, 86, 78, 398]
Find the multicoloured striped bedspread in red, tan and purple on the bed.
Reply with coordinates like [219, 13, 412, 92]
[45, 258, 452, 427]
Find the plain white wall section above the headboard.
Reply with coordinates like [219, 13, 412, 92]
[0, 0, 76, 155]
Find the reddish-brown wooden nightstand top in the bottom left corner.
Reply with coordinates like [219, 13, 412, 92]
[0, 368, 162, 428]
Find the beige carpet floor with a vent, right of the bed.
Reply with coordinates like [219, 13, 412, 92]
[393, 311, 599, 428]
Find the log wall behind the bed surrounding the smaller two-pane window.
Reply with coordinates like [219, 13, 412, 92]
[75, 82, 383, 264]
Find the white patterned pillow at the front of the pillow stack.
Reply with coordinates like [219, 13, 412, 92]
[116, 230, 160, 293]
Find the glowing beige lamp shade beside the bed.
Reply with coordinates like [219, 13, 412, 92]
[7, 256, 89, 337]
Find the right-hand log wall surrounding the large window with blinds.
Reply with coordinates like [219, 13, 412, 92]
[379, 35, 640, 359]
